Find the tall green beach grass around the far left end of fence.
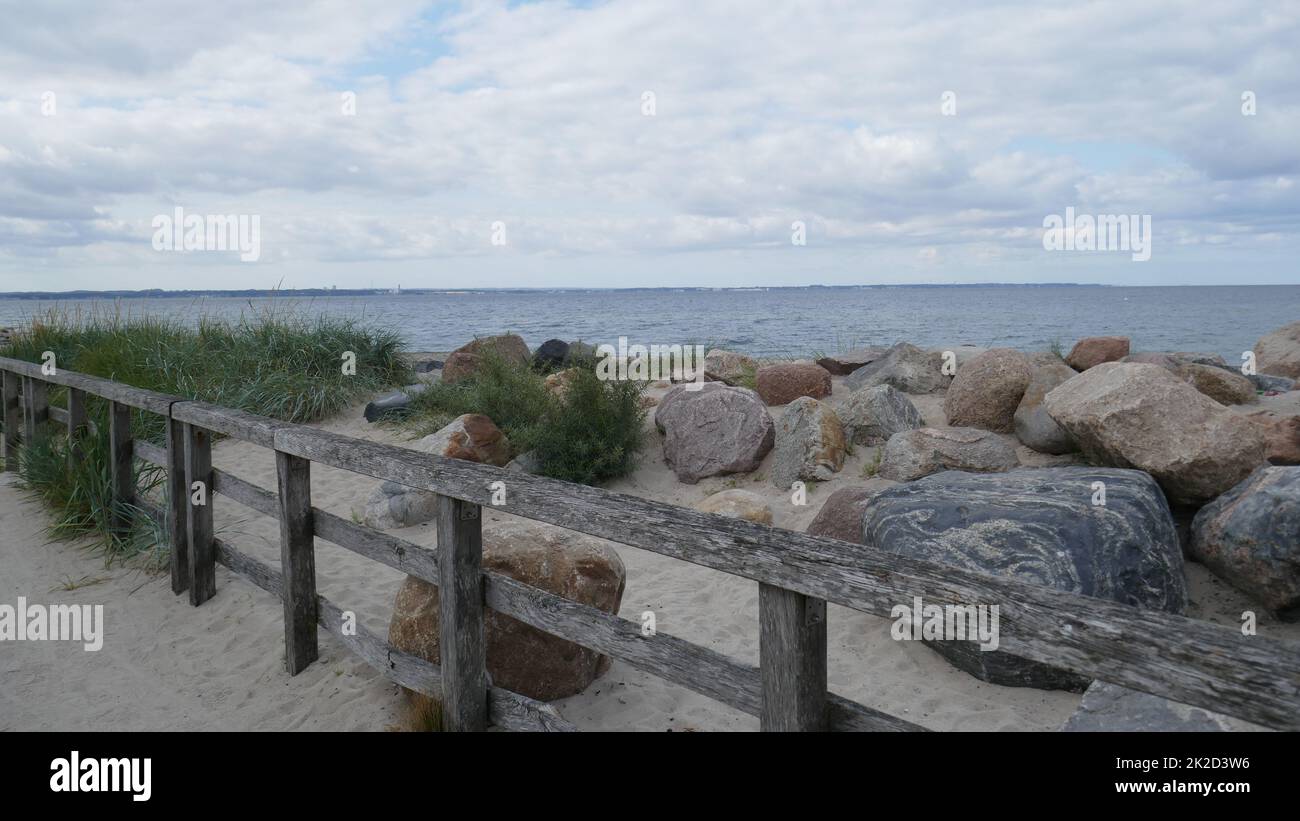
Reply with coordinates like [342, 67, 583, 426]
[4, 305, 412, 566]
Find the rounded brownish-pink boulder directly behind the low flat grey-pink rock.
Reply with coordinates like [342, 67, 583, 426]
[944, 348, 1032, 434]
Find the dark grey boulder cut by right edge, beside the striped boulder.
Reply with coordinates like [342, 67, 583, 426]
[1191, 468, 1300, 612]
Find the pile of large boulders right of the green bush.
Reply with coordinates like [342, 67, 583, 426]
[655, 322, 1300, 706]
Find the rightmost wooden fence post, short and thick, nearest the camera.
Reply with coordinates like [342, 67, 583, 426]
[758, 583, 827, 733]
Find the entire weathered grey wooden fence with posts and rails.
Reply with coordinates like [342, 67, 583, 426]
[0, 359, 1300, 730]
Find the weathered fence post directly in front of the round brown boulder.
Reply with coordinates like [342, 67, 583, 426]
[438, 495, 488, 733]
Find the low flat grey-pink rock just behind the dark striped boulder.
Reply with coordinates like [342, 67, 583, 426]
[880, 427, 1019, 482]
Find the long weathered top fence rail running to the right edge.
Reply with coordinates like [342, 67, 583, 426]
[276, 426, 1300, 729]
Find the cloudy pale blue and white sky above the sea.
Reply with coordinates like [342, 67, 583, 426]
[0, 0, 1300, 291]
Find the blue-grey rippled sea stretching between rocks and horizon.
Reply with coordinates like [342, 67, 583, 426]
[0, 284, 1300, 362]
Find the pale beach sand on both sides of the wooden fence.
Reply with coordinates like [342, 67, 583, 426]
[0, 378, 1300, 731]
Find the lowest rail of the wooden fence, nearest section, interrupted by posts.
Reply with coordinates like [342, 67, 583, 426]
[213, 539, 576, 733]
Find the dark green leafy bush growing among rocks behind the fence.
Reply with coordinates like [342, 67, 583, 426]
[398, 352, 646, 485]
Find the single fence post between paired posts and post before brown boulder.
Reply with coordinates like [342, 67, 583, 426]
[276, 451, 319, 676]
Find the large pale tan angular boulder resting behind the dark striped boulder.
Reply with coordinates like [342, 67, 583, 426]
[1043, 362, 1264, 505]
